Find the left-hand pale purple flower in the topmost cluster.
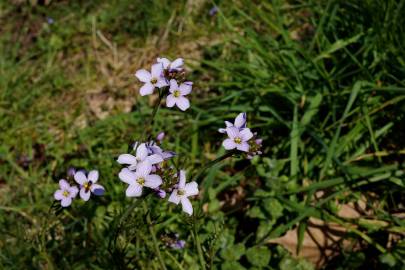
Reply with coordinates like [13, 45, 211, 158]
[135, 63, 168, 96]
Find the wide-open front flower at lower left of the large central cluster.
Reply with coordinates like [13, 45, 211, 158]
[118, 162, 162, 197]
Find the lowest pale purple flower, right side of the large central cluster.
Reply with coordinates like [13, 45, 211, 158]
[169, 170, 198, 216]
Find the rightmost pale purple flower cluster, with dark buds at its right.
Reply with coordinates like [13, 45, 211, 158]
[218, 113, 262, 159]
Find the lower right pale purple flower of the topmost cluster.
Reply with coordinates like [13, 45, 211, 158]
[166, 79, 192, 111]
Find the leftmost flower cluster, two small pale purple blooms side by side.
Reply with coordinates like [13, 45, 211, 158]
[53, 169, 105, 207]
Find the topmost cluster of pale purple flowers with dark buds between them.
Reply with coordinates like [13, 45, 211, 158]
[135, 58, 193, 111]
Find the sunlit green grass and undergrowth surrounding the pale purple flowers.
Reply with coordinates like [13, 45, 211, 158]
[0, 0, 405, 269]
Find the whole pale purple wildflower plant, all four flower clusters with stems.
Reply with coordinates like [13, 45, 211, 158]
[50, 58, 262, 269]
